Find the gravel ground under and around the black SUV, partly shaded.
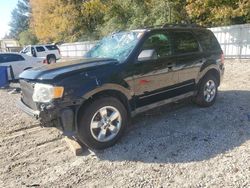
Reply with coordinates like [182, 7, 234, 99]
[0, 61, 250, 187]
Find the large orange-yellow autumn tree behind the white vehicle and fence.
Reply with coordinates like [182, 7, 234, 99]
[31, 0, 105, 42]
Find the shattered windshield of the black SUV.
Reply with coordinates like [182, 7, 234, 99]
[85, 32, 143, 62]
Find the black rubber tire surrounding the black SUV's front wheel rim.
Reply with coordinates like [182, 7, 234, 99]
[78, 97, 128, 150]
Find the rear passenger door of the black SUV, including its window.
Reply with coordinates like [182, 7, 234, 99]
[170, 31, 205, 89]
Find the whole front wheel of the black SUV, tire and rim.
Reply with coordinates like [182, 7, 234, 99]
[78, 97, 128, 150]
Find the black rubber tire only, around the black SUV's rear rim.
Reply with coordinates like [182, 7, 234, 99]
[194, 74, 218, 107]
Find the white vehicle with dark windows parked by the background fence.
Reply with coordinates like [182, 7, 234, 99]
[21, 44, 61, 64]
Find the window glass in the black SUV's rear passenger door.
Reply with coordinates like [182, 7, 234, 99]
[172, 32, 199, 54]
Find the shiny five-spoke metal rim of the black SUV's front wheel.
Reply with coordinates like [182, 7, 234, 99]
[90, 106, 122, 142]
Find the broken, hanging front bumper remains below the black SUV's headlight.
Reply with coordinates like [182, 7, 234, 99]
[17, 100, 76, 136]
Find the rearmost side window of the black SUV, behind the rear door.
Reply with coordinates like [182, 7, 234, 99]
[194, 30, 221, 51]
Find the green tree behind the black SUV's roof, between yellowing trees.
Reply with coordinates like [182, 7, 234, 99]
[99, 0, 188, 34]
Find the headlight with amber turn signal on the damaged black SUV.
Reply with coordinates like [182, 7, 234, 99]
[32, 83, 64, 103]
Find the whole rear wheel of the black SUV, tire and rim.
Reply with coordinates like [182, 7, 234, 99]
[194, 74, 218, 107]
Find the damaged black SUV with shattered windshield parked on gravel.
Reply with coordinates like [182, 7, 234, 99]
[19, 25, 224, 149]
